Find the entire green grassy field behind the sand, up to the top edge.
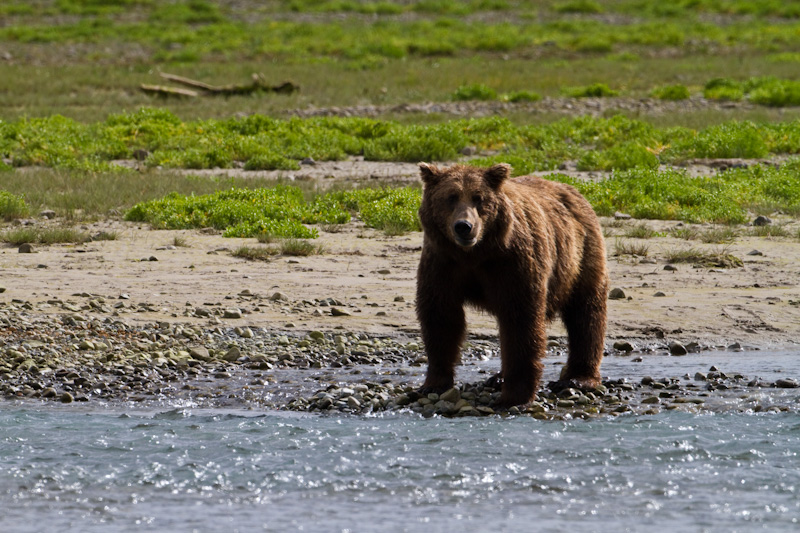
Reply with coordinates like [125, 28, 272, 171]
[0, 0, 800, 237]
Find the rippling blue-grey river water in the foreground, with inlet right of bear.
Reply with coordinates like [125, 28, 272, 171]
[0, 352, 800, 533]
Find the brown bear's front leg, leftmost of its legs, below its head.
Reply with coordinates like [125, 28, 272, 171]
[417, 254, 467, 394]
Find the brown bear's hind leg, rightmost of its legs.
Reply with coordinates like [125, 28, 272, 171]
[560, 285, 606, 388]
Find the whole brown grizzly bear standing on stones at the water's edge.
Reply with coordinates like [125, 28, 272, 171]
[416, 163, 608, 407]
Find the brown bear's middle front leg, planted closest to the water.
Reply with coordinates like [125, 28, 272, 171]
[497, 303, 547, 407]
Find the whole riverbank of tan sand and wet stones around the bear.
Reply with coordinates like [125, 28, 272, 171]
[0, 213, 800, 418]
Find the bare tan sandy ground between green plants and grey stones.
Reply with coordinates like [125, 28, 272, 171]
[0, 209, 800, 354]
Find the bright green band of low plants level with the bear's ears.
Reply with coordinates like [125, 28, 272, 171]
[6, 108, 800, 171]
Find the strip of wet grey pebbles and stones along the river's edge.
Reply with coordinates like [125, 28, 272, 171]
[0, 302, 798, 420]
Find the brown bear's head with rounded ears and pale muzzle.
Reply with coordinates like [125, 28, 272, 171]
[419, 163, 511, 250]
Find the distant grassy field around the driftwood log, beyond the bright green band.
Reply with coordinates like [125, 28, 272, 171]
[0, 0, 800, 122]
